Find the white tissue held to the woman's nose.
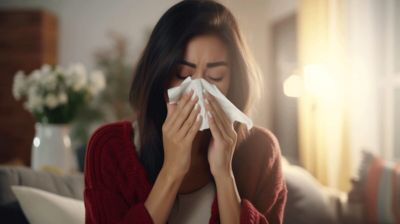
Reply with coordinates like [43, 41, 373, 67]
[168, 76, 253, 131]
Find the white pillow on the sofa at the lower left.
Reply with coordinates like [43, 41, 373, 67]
[11, 186, 85, 224]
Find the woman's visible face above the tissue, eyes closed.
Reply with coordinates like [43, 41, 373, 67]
[168, 35, 231, 96]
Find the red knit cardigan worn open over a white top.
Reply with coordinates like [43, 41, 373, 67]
[84, 121, 287, 224]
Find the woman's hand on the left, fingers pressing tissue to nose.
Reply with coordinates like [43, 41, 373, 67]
[162, 90, 201, 178]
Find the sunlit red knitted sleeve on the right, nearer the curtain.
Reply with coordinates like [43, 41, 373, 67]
[209, 128, 287, 224]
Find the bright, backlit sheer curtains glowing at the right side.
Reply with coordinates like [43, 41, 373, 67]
[298, 0, 400, 190]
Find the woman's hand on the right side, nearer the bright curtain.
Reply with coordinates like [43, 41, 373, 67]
[205, 92, 237, 178]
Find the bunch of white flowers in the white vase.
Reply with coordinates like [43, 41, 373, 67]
[13, 64, 106, 124]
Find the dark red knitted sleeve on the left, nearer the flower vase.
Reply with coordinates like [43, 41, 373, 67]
[84, 125, 153, 224]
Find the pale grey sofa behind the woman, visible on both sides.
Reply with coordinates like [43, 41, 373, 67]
[0, 160, 360, 224]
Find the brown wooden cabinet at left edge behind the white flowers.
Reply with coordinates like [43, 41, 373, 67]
[0, 9, 58, 165]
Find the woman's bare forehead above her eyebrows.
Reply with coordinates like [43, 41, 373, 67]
[185, 35, 228, 63]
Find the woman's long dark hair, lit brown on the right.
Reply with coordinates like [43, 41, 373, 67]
[129, 0, 259, 183]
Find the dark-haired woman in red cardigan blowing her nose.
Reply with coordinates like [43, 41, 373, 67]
[84, 0, 287, 223]
